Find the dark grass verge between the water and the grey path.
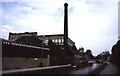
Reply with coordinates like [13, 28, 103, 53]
[89, 64, 107, 76]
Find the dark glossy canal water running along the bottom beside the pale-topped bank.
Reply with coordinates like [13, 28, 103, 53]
[2, 64, 99, 74]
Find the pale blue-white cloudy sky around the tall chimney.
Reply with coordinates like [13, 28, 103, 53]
[0, 0, 118, 55]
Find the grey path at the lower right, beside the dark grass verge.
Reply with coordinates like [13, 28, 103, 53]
[100, 63, 118, 74]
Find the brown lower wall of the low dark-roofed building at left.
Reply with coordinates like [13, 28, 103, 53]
[2, 55, 50, 70]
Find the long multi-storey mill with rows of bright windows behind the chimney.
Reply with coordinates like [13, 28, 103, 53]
[9, 32, 75, 48]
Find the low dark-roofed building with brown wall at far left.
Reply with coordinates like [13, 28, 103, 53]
[2, 40, 50, 70]
